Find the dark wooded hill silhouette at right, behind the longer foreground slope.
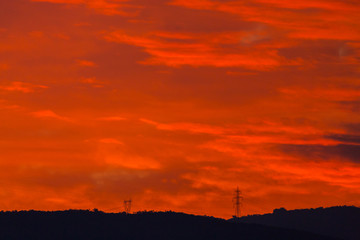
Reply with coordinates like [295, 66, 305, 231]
[238, 206, 360, 240]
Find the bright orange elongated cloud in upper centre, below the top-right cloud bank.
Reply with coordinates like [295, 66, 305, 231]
[105, 31, 299, 70]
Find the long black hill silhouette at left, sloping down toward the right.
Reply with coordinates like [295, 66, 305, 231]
[0, 210, 334, 240]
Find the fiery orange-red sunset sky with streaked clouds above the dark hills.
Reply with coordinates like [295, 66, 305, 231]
[0, 0, 360, 218]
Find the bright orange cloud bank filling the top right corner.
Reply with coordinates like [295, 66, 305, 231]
[171, 0, 360, 40]
